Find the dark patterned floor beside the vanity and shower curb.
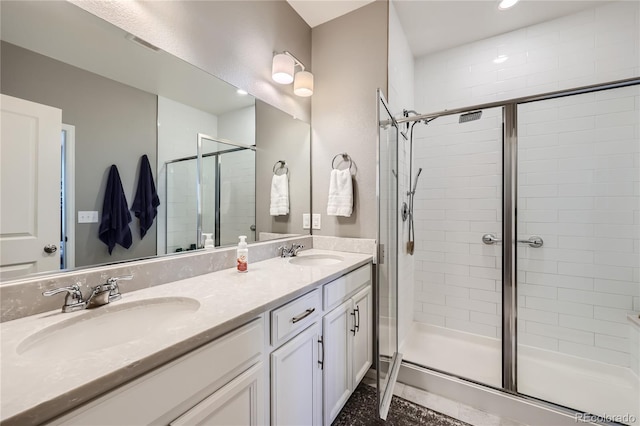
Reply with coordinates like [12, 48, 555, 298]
[332, 383, 468, 426]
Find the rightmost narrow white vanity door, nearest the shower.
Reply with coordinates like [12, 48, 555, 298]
[353, 286, 373, 389]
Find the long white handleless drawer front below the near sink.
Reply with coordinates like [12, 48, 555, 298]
[51, 318, 264, 426]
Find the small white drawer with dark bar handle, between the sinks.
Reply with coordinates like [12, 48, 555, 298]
[271, 289, 322, 346]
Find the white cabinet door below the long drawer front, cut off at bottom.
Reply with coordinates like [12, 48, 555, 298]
[170, 362, 265, 426]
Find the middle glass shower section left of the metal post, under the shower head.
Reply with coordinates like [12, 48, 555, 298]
[400, 107, 509, 388]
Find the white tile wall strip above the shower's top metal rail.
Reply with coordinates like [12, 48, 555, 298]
[415, 1, 640, 115]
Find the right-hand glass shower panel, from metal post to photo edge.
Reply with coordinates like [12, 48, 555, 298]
[516, 85, 640, 424]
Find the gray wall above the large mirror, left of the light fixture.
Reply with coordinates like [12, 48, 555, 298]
[71, 0, 313, 122]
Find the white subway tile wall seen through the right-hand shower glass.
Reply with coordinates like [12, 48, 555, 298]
[517, 86, 640, 367]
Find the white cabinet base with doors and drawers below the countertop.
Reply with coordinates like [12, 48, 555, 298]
[49, 264, 373, 426]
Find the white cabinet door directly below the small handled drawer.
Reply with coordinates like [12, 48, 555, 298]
[271, 323, 322, 426]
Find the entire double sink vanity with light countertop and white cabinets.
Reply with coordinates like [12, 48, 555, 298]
[0, 245, 373, 425]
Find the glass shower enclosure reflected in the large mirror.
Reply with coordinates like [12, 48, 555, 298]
[166, 134, 255, 253]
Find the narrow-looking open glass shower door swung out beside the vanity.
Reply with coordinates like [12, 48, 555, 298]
[376, 91, 402, 419]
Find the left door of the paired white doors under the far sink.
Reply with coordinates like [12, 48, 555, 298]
[322, 299, 355, 425]
